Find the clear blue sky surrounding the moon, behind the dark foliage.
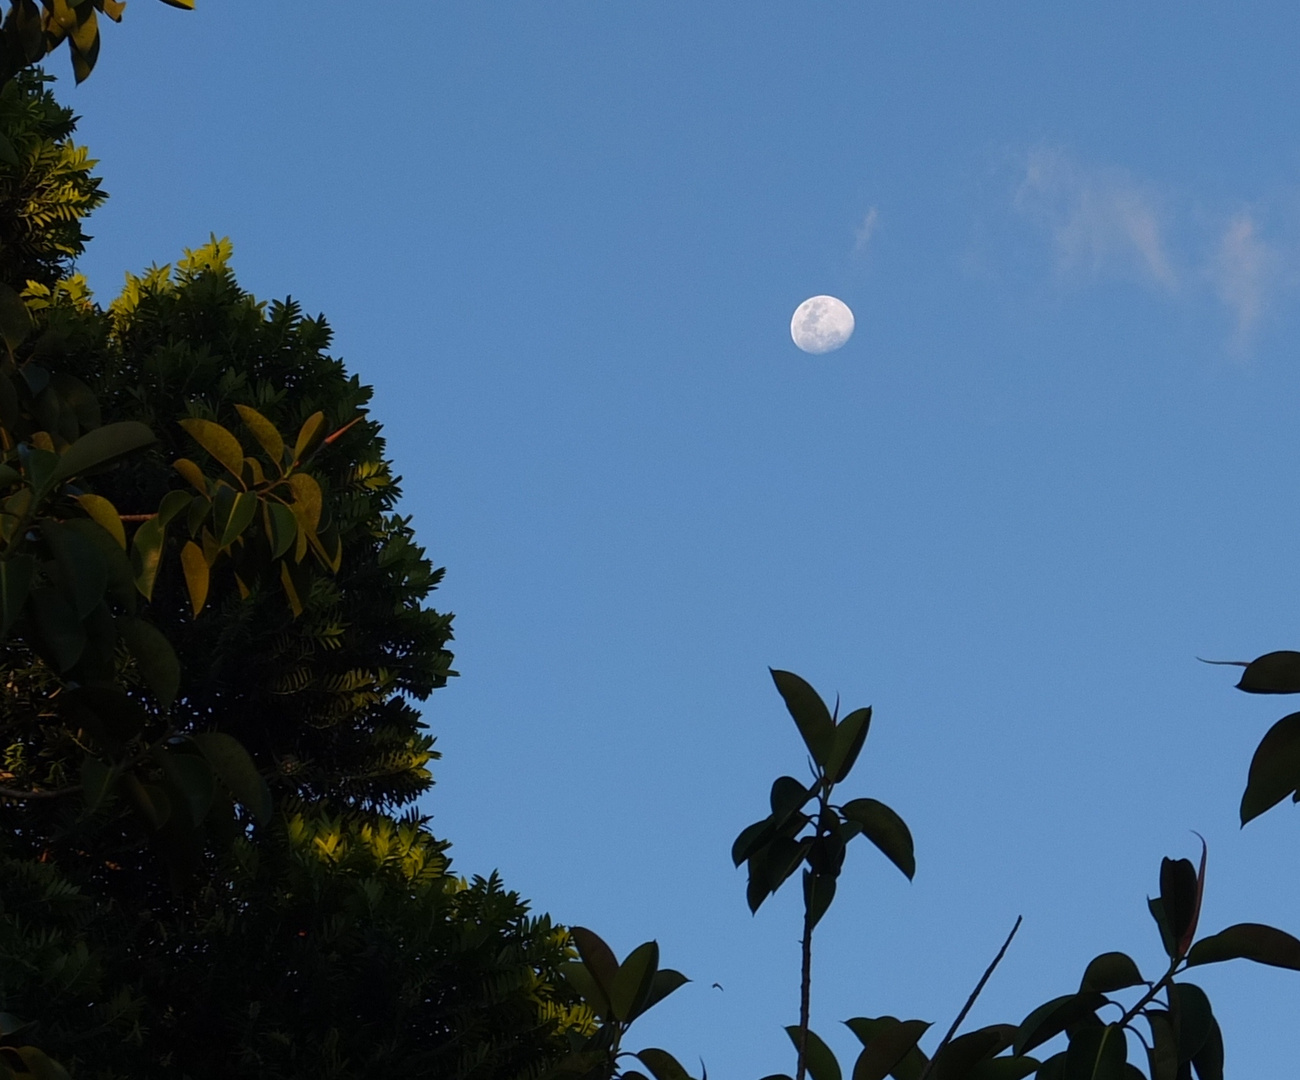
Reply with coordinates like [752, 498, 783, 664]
[65, 0, 1300, 1077]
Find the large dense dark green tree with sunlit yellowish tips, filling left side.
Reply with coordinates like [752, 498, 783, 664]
[0, 73, 594, 1080]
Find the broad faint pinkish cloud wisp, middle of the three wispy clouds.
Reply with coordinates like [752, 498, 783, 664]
[1014, 147, 1179, 292]
